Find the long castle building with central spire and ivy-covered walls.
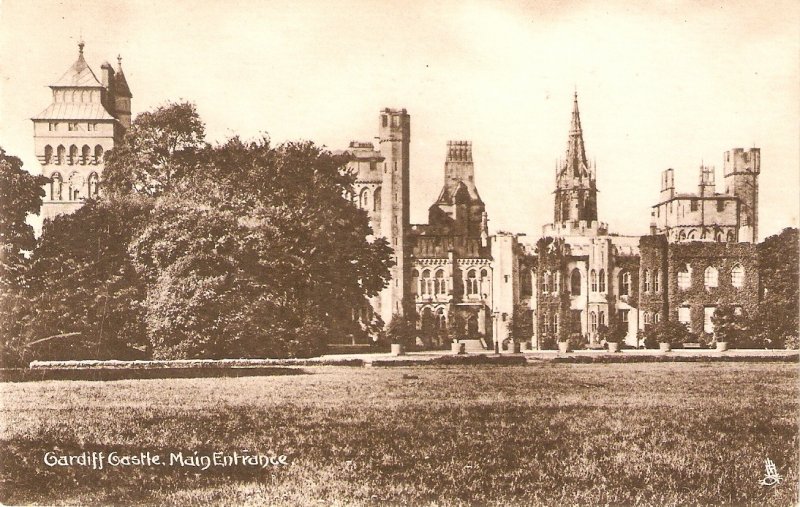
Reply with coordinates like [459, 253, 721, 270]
[347, 93, 760, 351]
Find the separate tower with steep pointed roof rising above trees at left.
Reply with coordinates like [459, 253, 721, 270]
[32, 42, 133, 219]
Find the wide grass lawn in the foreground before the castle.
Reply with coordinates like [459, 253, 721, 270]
[0, 363, 800, 505]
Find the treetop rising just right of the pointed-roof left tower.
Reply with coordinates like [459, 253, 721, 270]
[103, 102, 207, 197]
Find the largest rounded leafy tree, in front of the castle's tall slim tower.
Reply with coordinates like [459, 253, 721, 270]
[131, 138, 391, 357]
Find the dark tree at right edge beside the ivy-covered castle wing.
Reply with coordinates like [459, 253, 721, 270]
[753, 228, 800, 348]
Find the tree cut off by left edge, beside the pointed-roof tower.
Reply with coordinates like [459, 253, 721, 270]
[0, 147, 50, 292]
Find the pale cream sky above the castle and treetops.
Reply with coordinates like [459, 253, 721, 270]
[0, 0, 800, 241]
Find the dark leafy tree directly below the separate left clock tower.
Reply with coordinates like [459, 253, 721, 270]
[11, 197, 150, 366]
